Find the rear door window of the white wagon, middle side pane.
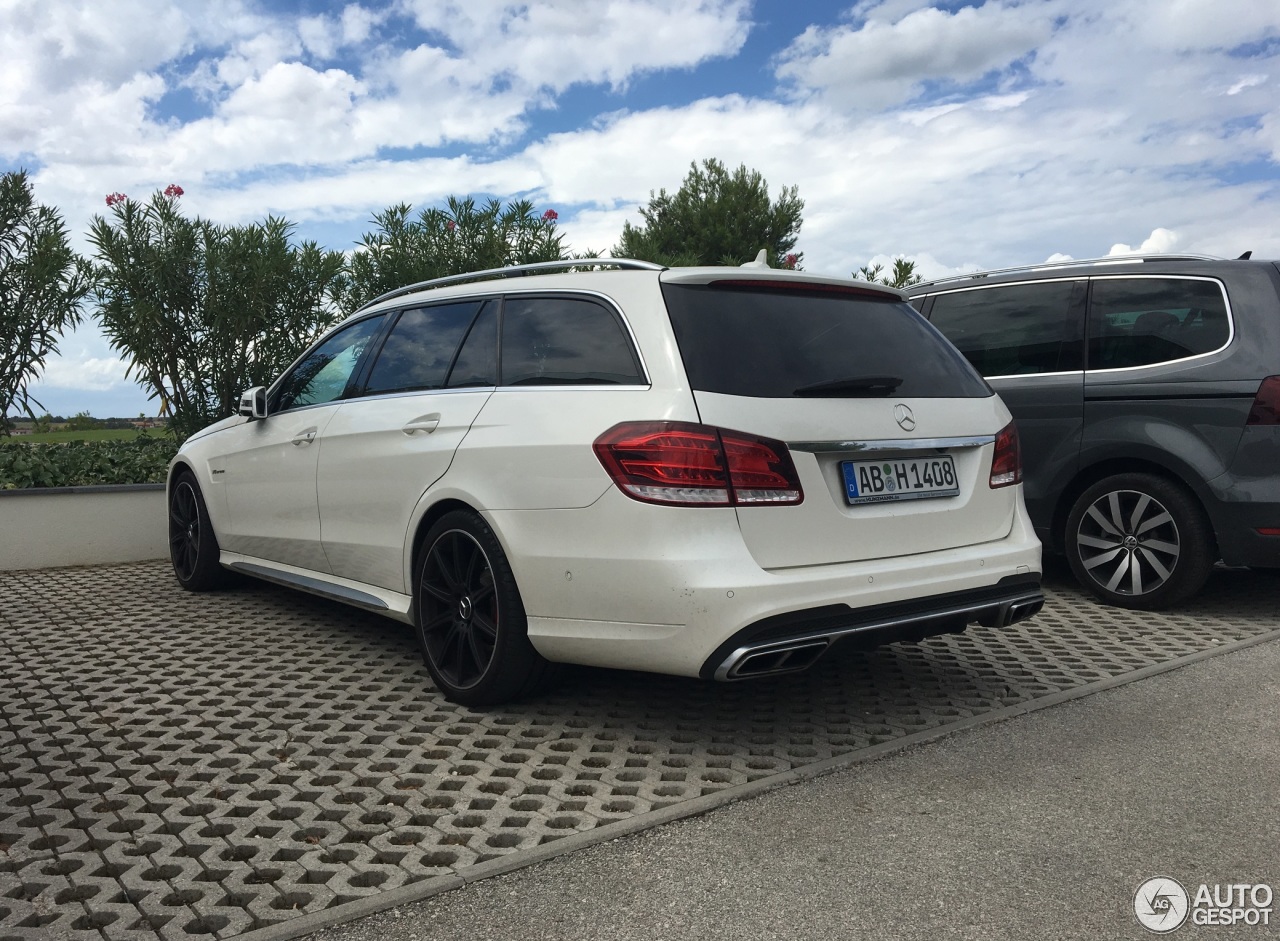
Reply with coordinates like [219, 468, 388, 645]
[364, 301, 480, 394]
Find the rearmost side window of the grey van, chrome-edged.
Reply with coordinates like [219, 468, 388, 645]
[1089, 278, 1230, 369]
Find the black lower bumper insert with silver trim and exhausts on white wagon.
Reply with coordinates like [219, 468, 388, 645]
[700, 574, 1044, 680]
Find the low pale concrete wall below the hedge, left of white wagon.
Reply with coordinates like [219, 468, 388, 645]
[0, 484, 169, 570]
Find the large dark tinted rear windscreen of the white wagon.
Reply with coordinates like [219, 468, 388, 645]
[662, 284, 992, 398]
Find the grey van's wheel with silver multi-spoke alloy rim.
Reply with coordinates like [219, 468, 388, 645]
[1064, 474, 1216, 611]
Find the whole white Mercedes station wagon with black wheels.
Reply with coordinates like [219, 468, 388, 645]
[168, 260, 1043, 705]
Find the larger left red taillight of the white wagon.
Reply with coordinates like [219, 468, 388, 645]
[594, 421, 804, 507]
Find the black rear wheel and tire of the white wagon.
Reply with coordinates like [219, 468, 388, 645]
[413, 511, 557, 707]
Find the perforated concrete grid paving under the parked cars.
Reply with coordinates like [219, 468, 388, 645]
[0, 563, 1280, 941]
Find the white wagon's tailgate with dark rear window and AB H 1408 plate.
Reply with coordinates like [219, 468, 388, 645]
[662, 269, 1019, 568]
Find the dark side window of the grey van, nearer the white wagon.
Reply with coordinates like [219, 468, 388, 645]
[929, 280, 1084, 376]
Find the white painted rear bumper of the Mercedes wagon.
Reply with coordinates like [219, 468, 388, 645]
[485, 489, 1041, 676]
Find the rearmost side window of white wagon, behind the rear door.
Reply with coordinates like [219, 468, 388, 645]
[502, 297, 644, 385]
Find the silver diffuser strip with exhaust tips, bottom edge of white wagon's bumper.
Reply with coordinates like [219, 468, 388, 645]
[714, 593, 1044, 680]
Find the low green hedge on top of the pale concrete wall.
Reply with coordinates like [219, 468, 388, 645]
[0, 437, 179, 490]
